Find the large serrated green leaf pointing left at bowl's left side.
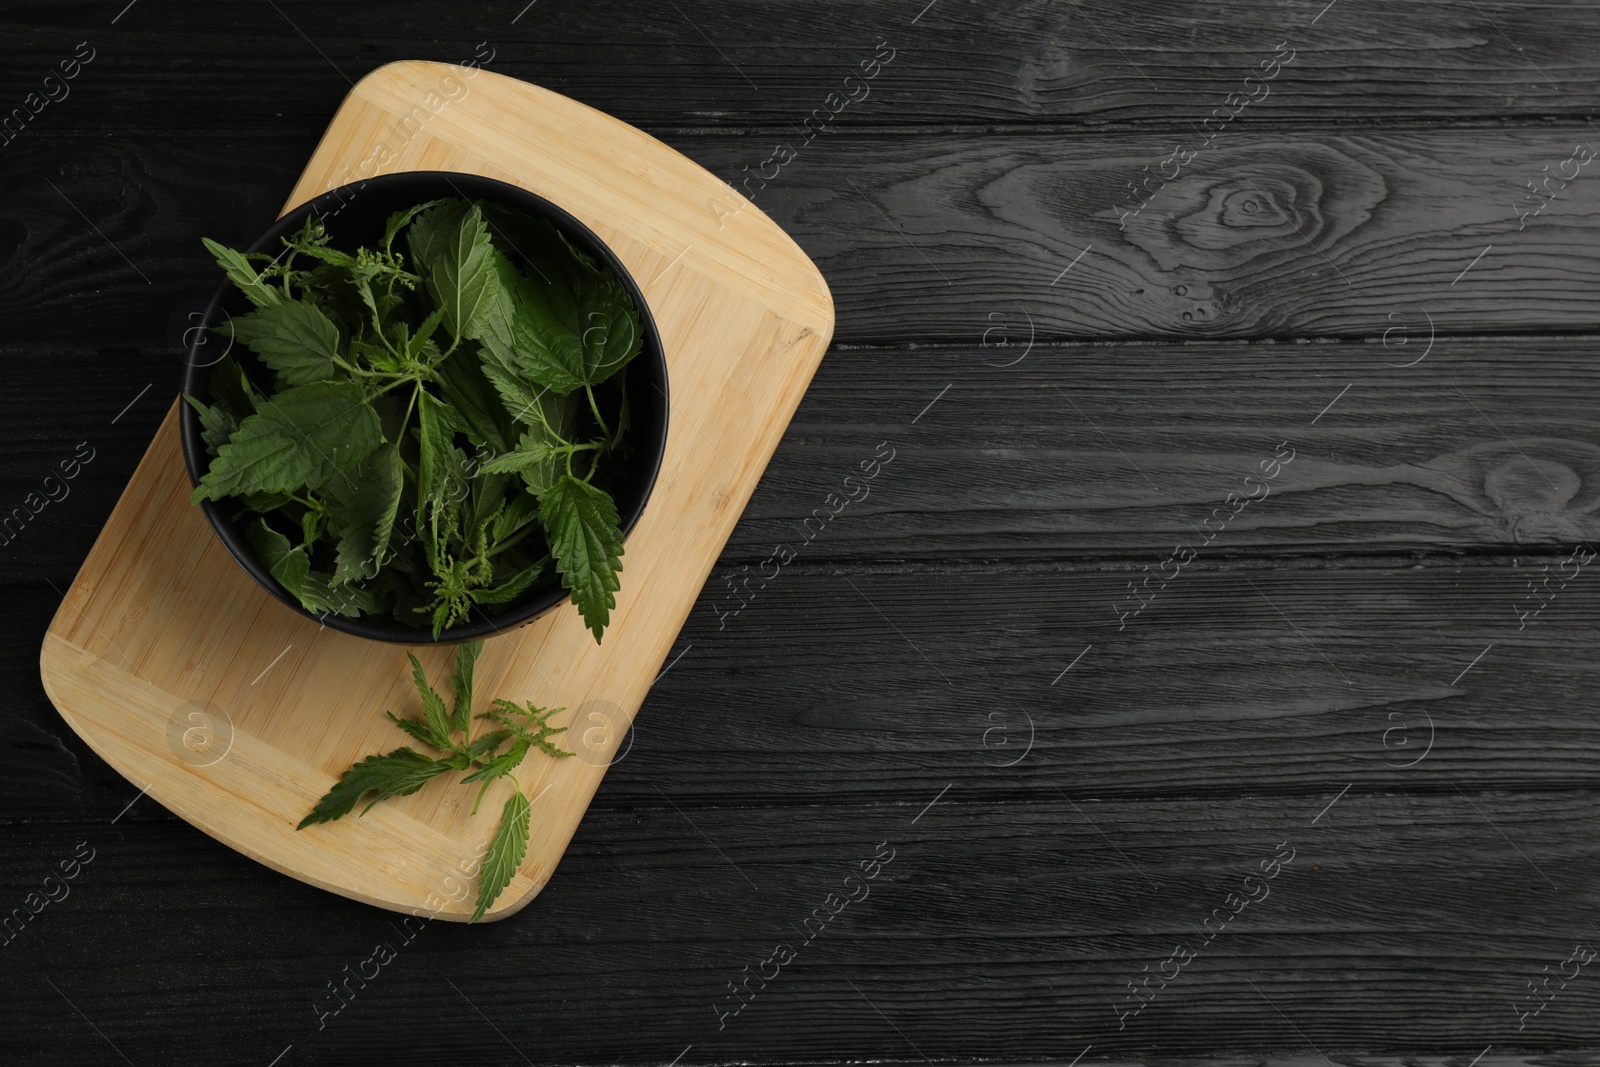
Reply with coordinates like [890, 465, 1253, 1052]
[190, 382, 381, 504]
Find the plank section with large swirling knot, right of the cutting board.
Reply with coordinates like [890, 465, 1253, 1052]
[768, 128, 1600, 344]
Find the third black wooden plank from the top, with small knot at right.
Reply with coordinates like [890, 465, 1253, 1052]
[0, 335, 1600, 585]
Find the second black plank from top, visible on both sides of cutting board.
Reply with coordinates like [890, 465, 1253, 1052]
[0, 127, 1600, 349]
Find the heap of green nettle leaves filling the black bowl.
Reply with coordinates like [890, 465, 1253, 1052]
[186, 198, 643, 641]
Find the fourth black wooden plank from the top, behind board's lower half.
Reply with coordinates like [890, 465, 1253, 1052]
[12, 555, 1600, 817]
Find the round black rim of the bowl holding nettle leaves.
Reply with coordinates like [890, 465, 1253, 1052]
[178, 171, 672, 645]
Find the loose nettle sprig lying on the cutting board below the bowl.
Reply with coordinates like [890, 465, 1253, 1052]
[294, 641, 573, 923]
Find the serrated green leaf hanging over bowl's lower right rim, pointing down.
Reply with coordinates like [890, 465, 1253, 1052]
[539, 474, 622, 643]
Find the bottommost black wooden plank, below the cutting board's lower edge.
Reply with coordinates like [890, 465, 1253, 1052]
[0, 793, 1600, 1067]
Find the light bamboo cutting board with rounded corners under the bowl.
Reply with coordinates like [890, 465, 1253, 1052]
[40, 61, 834, 921]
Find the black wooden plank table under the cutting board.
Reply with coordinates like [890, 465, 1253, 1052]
[0, 0, 1600, 1067]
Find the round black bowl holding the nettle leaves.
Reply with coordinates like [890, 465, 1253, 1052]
[179, 171, 669, 645]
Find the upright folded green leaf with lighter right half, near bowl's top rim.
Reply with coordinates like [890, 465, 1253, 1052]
[406, 200, 502, 347]
